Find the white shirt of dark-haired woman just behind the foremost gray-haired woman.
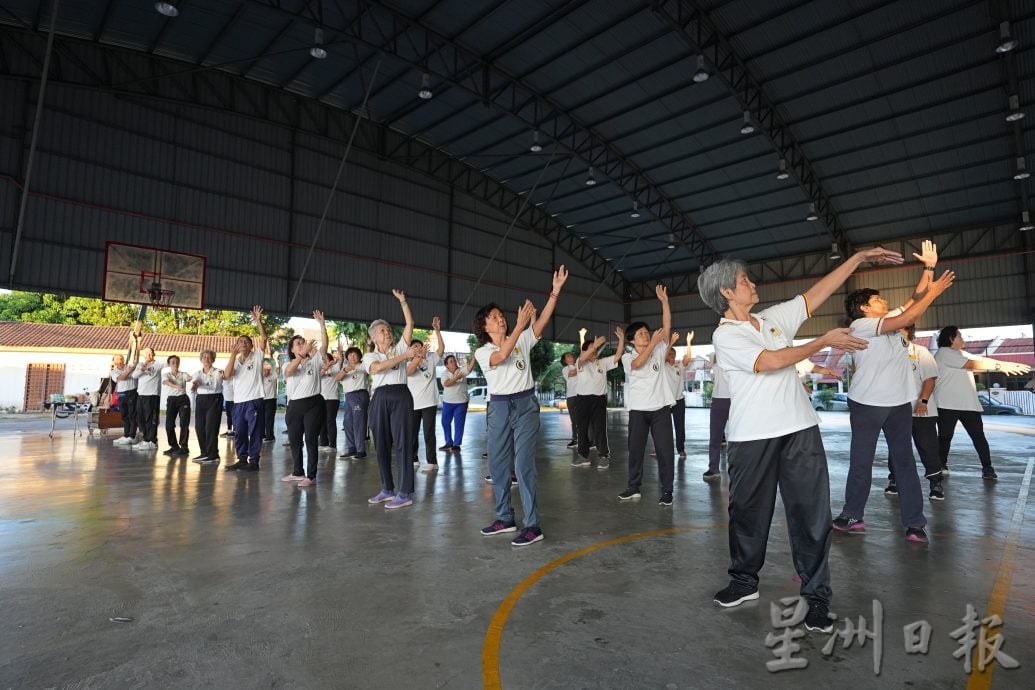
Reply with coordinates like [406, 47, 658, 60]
[848, 307, 919, 408]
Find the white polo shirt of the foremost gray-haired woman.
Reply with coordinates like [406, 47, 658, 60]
[712, 295, 820, 442]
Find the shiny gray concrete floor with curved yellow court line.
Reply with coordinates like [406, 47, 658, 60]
[0, 410, 1035, 689]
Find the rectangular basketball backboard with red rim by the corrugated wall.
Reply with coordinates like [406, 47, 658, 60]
[104, 242, 207, 309]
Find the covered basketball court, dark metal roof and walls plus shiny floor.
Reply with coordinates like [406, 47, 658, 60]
[0, 0, 1035, 688]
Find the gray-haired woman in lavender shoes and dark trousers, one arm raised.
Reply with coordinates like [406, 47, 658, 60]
[363, 290, 423, 510]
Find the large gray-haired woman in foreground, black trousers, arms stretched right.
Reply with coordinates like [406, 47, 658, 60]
[698, 247, 903, 632]
